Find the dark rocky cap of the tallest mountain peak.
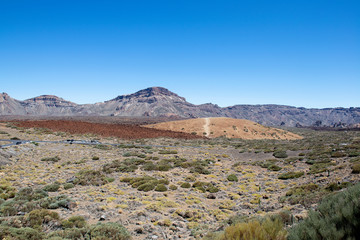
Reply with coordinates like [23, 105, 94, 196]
[110, 87, 186, 102]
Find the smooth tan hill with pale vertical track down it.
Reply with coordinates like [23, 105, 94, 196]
[144, 117, 302, 140]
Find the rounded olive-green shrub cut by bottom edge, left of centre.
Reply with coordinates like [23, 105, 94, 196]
[89, 222, 131, 240]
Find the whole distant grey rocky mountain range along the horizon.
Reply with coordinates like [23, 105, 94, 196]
[0, 87, 360, 127]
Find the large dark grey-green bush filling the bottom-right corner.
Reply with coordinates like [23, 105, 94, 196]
[289, 184, 360, 240]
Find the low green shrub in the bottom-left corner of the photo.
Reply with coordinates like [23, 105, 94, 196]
[0, 225, 43, 240]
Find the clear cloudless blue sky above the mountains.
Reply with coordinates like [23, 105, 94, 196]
[0, 0, 360, 108]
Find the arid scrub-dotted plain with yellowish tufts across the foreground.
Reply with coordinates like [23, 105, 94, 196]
[0, 119, 360, 239]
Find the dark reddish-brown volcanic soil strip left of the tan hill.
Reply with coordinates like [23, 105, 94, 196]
[15, 120, 202, 139]
